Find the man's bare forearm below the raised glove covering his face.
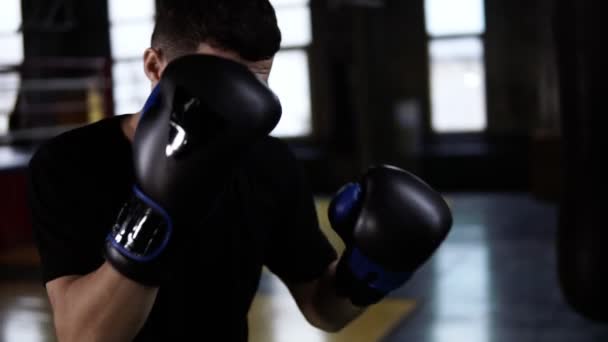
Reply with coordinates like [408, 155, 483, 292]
[53, 263, 158, 342]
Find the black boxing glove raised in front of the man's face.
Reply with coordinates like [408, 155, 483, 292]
[104, 54, 281, 286]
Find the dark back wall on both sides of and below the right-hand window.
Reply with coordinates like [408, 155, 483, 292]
[306, 0, 559, 191]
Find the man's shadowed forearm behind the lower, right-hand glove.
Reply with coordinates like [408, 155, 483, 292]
[313, 261, 366, 331]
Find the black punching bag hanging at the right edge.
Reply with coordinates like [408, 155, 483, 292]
[555, 0, 608, 322]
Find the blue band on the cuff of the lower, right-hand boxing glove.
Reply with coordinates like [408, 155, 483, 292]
[348, 248, 412, 293]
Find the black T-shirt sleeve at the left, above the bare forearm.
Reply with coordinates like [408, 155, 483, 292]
[28, 146, 101, 284]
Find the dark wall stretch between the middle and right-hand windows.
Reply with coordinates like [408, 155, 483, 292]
[311, 1, 428, 190]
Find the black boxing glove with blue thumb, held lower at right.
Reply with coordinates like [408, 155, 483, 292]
[328, 165, 452, 306]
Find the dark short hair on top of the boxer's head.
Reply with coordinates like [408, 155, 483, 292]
[152, 0, 281, 61]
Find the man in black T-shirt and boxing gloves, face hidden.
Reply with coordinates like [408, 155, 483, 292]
[30, 0, 451, 342]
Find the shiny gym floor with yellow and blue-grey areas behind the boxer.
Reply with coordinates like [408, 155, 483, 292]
[0, 194, 608, 342]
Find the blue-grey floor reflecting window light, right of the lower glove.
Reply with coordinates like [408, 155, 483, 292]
[385, 194, 608, 342]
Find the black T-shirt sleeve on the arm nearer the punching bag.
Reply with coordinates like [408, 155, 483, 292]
[265, 139, 337, 283]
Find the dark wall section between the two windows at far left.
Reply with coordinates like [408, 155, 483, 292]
[10, 0, 113, 130]
